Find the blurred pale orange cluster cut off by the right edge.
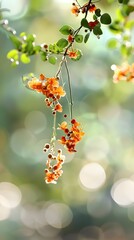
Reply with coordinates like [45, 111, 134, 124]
[111, 63, 134, 83]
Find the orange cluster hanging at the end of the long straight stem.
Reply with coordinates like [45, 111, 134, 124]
[58, 119, 84, 152]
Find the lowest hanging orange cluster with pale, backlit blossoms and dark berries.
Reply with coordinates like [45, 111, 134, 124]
[44, 143, 65, 184]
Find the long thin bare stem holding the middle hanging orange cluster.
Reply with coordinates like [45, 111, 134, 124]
[65, 59, 73, 120]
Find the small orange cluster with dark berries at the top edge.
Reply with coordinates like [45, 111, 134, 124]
[71, 3, 96, 16]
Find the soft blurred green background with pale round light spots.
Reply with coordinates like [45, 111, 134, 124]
[0, 0, 134, 240]
